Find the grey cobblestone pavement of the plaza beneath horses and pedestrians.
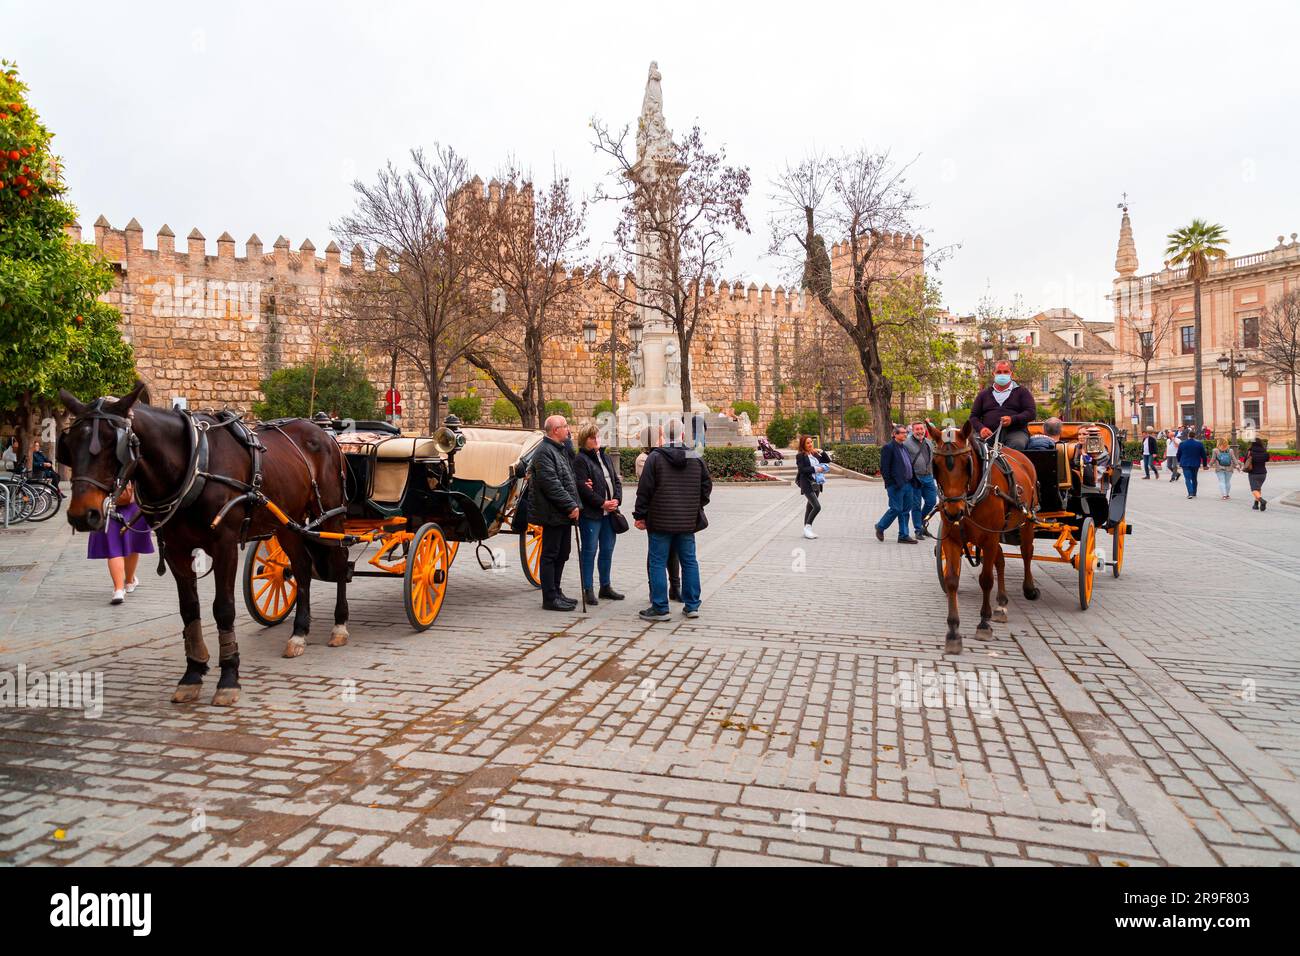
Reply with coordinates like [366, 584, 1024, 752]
[0, 466, 1300, 866]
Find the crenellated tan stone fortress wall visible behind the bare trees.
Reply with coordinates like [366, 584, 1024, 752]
[78, 216, 924, 428]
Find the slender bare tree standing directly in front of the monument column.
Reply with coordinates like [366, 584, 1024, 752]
[592, 120, 750, 412]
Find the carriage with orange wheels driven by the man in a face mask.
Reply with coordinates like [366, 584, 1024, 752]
[935, 421, 1132, 610]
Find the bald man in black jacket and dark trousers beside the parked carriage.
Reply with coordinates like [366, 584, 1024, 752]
[528, 415, 580, 611]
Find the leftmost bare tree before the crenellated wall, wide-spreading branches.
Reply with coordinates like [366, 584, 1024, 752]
[334, 146, 497, 431]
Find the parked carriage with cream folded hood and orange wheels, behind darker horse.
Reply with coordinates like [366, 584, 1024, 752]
[243, 418, 542, 631]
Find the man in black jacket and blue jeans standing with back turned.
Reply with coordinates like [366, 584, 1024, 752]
[632, 419, 714, 620]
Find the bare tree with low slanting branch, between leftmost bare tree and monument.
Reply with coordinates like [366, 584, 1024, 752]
[454, 169, 602, 428]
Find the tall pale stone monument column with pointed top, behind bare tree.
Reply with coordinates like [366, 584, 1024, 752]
[619, 62, 709, 445]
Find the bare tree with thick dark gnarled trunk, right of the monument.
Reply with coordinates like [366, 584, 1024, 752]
[770, 150, 946, 429]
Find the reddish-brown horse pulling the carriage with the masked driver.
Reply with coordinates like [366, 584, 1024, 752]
[927, 420, 1039, 654]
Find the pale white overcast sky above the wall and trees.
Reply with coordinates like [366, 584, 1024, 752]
[10, 0, 1300, 319]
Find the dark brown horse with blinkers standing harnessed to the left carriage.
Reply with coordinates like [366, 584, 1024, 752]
[59, 382, 348, 705]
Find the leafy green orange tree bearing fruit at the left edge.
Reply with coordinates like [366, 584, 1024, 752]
[0, 60, 135, 455]
